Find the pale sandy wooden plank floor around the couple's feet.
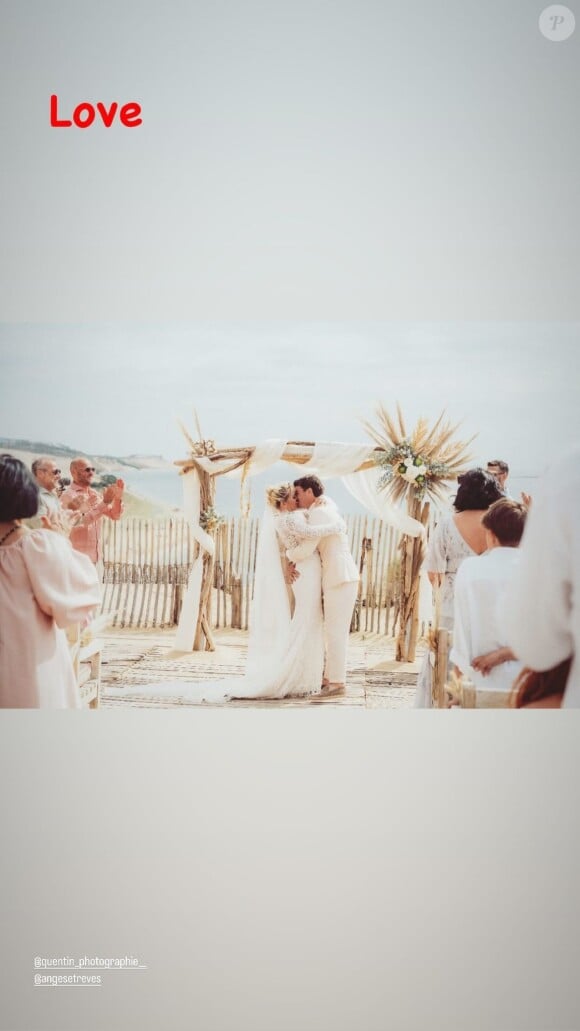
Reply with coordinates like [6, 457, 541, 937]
[101, 629, 422, 708]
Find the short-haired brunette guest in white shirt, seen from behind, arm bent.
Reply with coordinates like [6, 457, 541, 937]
[449, 498, 526, 692]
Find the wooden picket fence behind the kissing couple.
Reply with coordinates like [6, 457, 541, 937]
[102, 516, 400, 634]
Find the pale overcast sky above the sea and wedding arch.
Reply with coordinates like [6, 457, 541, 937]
[0, 323, 580, 473]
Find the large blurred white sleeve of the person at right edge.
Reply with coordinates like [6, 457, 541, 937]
[501, 470, 578, 670]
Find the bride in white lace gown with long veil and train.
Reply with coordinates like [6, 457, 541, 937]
[115, 483, 346, 702]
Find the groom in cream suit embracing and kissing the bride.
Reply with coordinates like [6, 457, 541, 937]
[294, 476, 359, 695]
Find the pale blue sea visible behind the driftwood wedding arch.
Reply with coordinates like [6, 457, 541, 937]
[121, 462, 538, 516]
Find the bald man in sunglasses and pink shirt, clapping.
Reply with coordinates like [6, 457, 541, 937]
[61, 458, 125, 565]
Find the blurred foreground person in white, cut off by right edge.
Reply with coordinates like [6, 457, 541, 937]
[503, 444, 580, 708]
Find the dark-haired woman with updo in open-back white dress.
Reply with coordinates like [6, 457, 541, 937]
[415, 468, 504, 708]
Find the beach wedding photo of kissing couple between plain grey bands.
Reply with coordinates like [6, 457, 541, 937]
[0, 323, 580, 709]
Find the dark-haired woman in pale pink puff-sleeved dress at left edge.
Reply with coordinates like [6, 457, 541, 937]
[0, 455, 100, 708]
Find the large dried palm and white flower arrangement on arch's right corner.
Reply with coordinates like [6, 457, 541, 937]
[366, 405, 471, 501]
